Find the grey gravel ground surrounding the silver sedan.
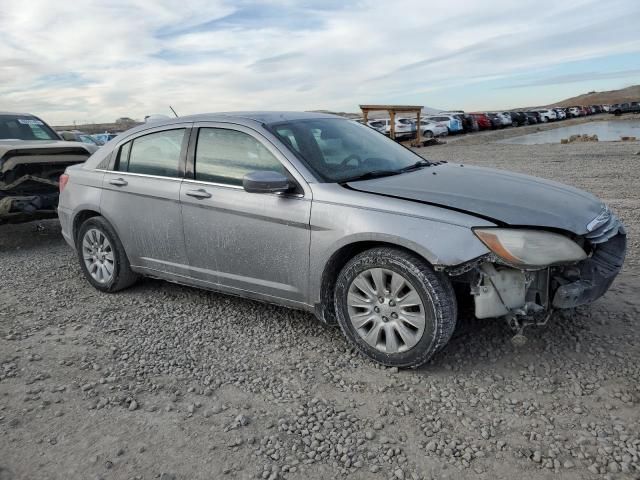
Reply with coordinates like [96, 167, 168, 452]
[0, 127, 640, 480]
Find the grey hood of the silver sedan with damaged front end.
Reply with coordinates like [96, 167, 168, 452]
[348, 163, 605, 235]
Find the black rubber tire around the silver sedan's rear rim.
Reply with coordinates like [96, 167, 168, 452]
[76, 216, 138, 293]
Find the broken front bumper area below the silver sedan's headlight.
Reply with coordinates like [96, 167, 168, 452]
[466, 231, 627, 318]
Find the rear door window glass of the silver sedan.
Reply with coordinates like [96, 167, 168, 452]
[116, 128, 185, 177]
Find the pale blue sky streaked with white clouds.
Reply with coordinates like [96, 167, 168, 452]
[0, 0, 640, 123]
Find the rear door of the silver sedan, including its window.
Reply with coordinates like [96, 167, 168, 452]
[101, 124, 190, 274]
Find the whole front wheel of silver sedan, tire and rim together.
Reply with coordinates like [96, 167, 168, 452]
[334, 247, 457, 367]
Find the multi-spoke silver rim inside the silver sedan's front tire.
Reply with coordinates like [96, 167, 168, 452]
[347, 268, 426, 353]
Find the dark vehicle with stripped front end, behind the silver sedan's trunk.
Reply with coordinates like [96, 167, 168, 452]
[0, 112, 98, 224]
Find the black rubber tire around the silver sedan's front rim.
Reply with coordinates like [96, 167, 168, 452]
[334, 247, 457, 367]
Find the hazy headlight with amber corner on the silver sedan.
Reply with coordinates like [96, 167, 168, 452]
[473, 228, 587, 267]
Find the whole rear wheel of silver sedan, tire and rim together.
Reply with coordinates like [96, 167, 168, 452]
[76, 217, 137, 292]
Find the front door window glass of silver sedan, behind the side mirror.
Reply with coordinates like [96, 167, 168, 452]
[195, 128, 286, 186]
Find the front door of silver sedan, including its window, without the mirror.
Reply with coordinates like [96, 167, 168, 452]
[180, 124, 311, 303]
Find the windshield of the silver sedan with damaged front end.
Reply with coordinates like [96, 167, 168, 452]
[269, 118, 424, 183]
